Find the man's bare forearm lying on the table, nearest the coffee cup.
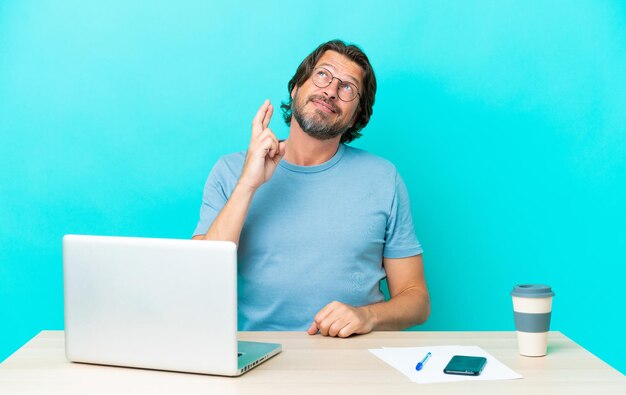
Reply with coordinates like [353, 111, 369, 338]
[361, 288, 430, 331]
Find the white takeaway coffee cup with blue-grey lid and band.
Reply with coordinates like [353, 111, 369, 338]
[511, 284, 554, 357]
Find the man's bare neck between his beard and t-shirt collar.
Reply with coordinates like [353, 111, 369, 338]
[283, 119, 341, 166]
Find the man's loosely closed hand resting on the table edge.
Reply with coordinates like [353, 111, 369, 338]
[307, 301, 374, 337]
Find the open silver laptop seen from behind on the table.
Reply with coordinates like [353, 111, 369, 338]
[63, 235, 281, 376]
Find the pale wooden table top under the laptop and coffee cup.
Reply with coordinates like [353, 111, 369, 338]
[0, 331, 626, 395]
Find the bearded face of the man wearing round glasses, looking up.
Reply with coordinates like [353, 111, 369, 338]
[291, 51, 363, 140]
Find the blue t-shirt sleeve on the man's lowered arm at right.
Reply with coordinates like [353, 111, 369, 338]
[383, 172, 423, 258]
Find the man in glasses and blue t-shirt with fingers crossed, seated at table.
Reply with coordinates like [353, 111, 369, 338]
[193, 40, 430, 337]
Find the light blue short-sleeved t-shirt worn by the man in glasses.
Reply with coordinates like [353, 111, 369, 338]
[194, 144, 422, 331]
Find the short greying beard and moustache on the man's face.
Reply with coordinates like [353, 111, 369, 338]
[291, 91, 349, 140]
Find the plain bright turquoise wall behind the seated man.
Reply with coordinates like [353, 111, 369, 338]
[0, 0, 626, 372]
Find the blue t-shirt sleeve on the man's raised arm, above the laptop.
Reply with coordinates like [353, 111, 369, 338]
[193, 159, 228, 236]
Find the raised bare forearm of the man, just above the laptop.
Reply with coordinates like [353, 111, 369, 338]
[204, 184, 255, 245]
